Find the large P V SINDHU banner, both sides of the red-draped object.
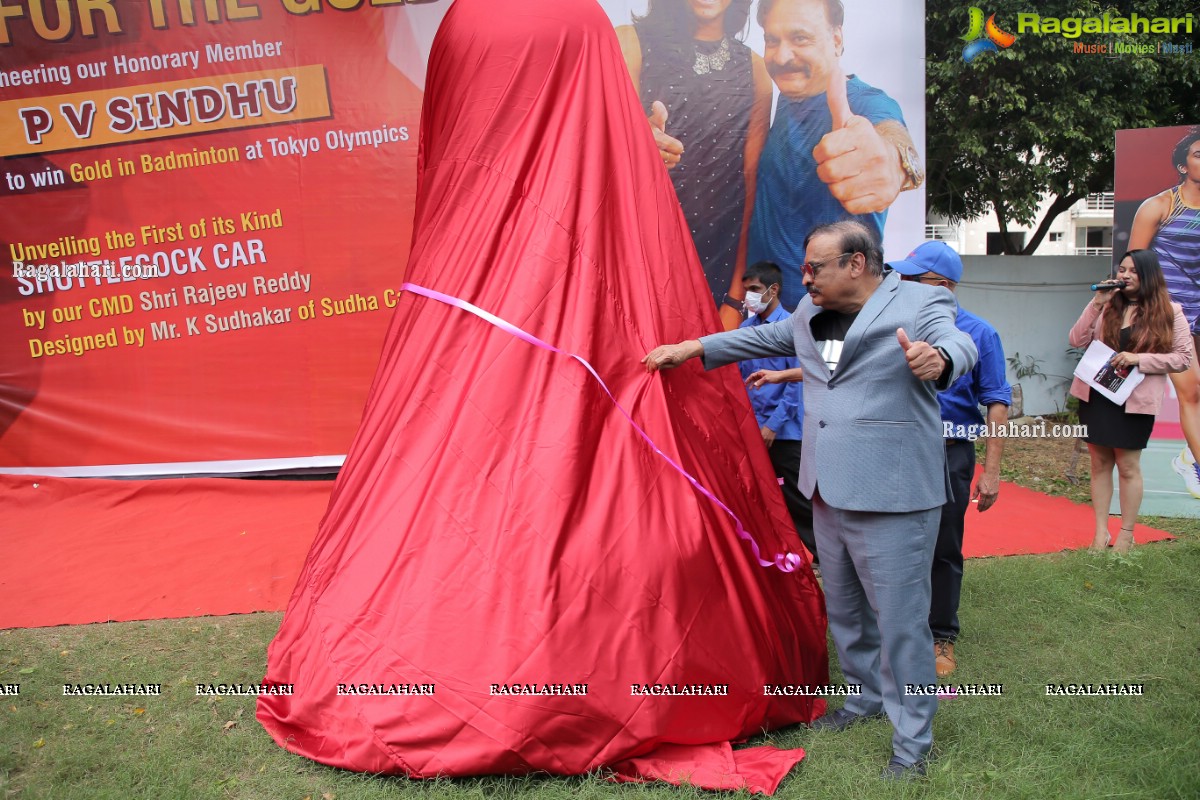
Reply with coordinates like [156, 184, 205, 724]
[0, 0, 924, 475]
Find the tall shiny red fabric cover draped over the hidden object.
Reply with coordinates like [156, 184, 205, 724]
[258, 0, 828, 787]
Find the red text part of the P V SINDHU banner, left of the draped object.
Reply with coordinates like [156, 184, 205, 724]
[0, 0, 445, 475]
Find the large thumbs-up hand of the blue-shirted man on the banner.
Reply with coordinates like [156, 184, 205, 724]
[812, 67, 907, 213]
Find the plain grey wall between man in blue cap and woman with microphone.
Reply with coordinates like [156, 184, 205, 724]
[958, 255, 1111, 415]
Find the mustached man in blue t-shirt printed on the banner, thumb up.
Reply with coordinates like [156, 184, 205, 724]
[748, 0, 925, 309]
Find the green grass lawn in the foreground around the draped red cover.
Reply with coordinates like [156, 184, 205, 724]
[0, 519, 1200, 800]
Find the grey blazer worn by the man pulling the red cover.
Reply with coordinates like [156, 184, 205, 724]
[700, 270, 978, 511]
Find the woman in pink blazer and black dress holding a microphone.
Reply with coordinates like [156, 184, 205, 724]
[1069, 249, 1193, 553]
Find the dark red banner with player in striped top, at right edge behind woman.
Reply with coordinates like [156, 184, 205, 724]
[1112, 124, 1200, 506]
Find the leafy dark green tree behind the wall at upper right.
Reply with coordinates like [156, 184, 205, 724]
[925, 0, 1200, 254]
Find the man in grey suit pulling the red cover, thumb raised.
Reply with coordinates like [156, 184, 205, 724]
[642, 221, 977, 780]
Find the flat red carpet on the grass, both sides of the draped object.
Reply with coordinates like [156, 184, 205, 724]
[0, 475, 1170, 628]
